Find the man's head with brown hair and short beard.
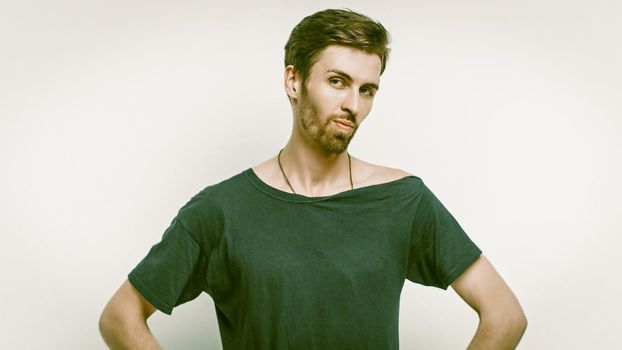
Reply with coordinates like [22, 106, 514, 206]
[285, 10, 389, 154]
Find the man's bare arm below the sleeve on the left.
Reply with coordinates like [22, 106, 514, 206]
[99, 280, 160, 350]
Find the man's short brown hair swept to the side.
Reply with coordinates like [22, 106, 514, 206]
[285, 9, 390, 83]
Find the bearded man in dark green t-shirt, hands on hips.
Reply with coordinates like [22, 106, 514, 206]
[100, 10, 526, 349]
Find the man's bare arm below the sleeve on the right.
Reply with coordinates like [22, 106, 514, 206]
[451, 256, 527, 350]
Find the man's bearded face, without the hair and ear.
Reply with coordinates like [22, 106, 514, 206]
[297, 46, 381, 154]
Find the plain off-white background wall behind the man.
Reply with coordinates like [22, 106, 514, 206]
[0, 0, 622, 349]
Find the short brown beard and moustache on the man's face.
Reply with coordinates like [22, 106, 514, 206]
[298, 88, 358, 154]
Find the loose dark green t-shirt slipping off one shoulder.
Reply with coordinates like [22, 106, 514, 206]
[129, 169, 481, 350]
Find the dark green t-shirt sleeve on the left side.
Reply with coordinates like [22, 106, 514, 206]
[128, 191, 216, 315]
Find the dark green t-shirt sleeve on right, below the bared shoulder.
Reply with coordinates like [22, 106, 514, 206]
[406, 182, 482, 289]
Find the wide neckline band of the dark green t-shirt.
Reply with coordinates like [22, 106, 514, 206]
[243, 168, 417, 203]
